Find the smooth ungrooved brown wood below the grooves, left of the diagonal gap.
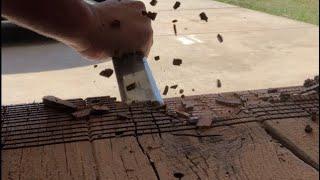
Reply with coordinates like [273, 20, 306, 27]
[2, 122, 319, 179]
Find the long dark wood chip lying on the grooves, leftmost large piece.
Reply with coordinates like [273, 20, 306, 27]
[42, 96, 77, 112]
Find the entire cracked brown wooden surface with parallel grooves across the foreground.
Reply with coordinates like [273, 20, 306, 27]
[1, 89, 319, 180]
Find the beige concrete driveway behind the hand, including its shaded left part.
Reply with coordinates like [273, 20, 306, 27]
[2, 0, 319, 104]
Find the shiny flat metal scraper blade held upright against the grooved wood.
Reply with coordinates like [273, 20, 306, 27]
[112, 54, 163, 105]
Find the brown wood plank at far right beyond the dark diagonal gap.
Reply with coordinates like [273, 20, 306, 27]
[264, 118, 319, 170]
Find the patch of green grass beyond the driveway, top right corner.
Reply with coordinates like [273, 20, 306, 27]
[216, 0, 319, 25]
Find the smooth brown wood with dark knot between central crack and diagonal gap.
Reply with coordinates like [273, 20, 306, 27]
[139, 122, 319, 179]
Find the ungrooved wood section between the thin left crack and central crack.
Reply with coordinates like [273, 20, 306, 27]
[92, 137, 156, 180]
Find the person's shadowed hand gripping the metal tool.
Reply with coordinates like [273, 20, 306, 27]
[76, 0, 153, 60]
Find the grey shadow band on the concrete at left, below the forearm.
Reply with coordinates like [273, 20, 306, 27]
[1, 42, 101, 74]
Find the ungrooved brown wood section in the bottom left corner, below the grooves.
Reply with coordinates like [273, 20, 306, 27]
[2, 142, 97, 180]
